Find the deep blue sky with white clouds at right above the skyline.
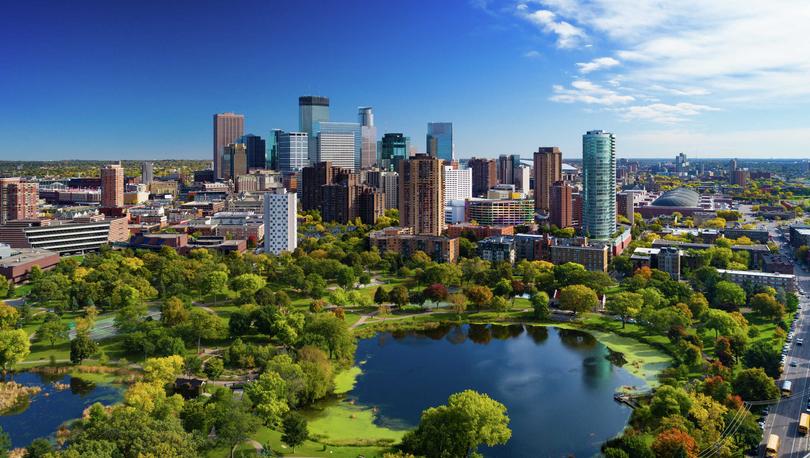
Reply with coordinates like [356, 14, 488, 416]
[0, 0, 810, 160]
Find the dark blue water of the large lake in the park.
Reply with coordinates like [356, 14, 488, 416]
[349, 325, 643, 457]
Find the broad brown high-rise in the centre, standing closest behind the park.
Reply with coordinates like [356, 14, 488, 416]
[399, 154, 444, 235]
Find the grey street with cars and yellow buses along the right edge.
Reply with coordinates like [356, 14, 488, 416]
[760, 224, 810, 458]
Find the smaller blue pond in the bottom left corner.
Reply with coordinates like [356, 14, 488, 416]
[0, 372, 121, 447]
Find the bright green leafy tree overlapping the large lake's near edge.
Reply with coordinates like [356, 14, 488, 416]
[402, 390, 512, 457]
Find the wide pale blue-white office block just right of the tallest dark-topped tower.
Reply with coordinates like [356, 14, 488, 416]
[317, 122, 363, 172]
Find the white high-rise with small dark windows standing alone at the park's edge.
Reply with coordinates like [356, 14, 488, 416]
[263, 188, 298, 255]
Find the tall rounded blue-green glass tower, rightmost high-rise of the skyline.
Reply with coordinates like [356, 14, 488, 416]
[582, 130, 616, 240]
